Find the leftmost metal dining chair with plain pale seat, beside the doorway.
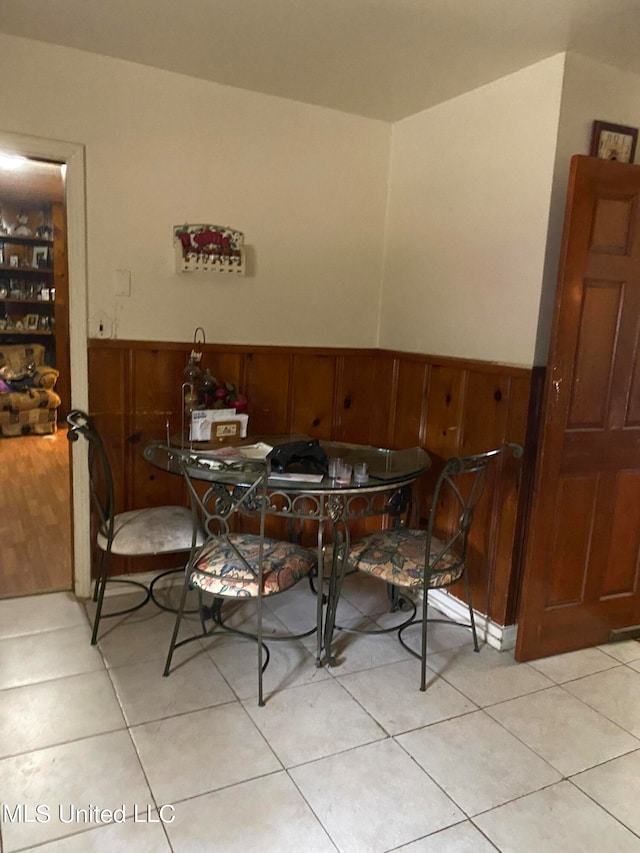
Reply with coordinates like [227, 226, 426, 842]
[67, 409, 203, 645]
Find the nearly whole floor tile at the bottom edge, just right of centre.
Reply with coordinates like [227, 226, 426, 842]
[291, 740, 464, 853]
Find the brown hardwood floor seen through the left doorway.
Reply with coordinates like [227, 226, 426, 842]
[0, 428, 72, 598]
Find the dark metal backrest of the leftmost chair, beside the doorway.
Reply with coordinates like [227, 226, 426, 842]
[67, 409, 115, 547]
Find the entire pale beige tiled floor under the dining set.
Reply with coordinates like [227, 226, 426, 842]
[0, 578, 640, 853]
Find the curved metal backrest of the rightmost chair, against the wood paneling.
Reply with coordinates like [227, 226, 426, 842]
[427, 444, 522, 573]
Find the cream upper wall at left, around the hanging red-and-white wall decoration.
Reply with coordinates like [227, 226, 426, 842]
[0, 36, 391, 347]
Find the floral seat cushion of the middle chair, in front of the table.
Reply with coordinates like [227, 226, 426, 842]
[191, 533, 317, 598]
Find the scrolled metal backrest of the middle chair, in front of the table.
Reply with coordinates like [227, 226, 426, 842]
[180, 455, 271, 589]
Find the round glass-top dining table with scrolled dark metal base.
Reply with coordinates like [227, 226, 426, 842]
[143, 435, 431, 666]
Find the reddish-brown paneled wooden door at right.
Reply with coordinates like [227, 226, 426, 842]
[516, 157, 640, 660]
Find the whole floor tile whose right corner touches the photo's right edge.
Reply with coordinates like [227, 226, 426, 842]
[487, 687, 638, 776]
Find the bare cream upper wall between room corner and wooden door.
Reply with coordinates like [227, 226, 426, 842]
[380, 55, 564, 366]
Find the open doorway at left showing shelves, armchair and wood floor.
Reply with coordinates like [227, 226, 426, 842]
[0, 152, 73, 597]
